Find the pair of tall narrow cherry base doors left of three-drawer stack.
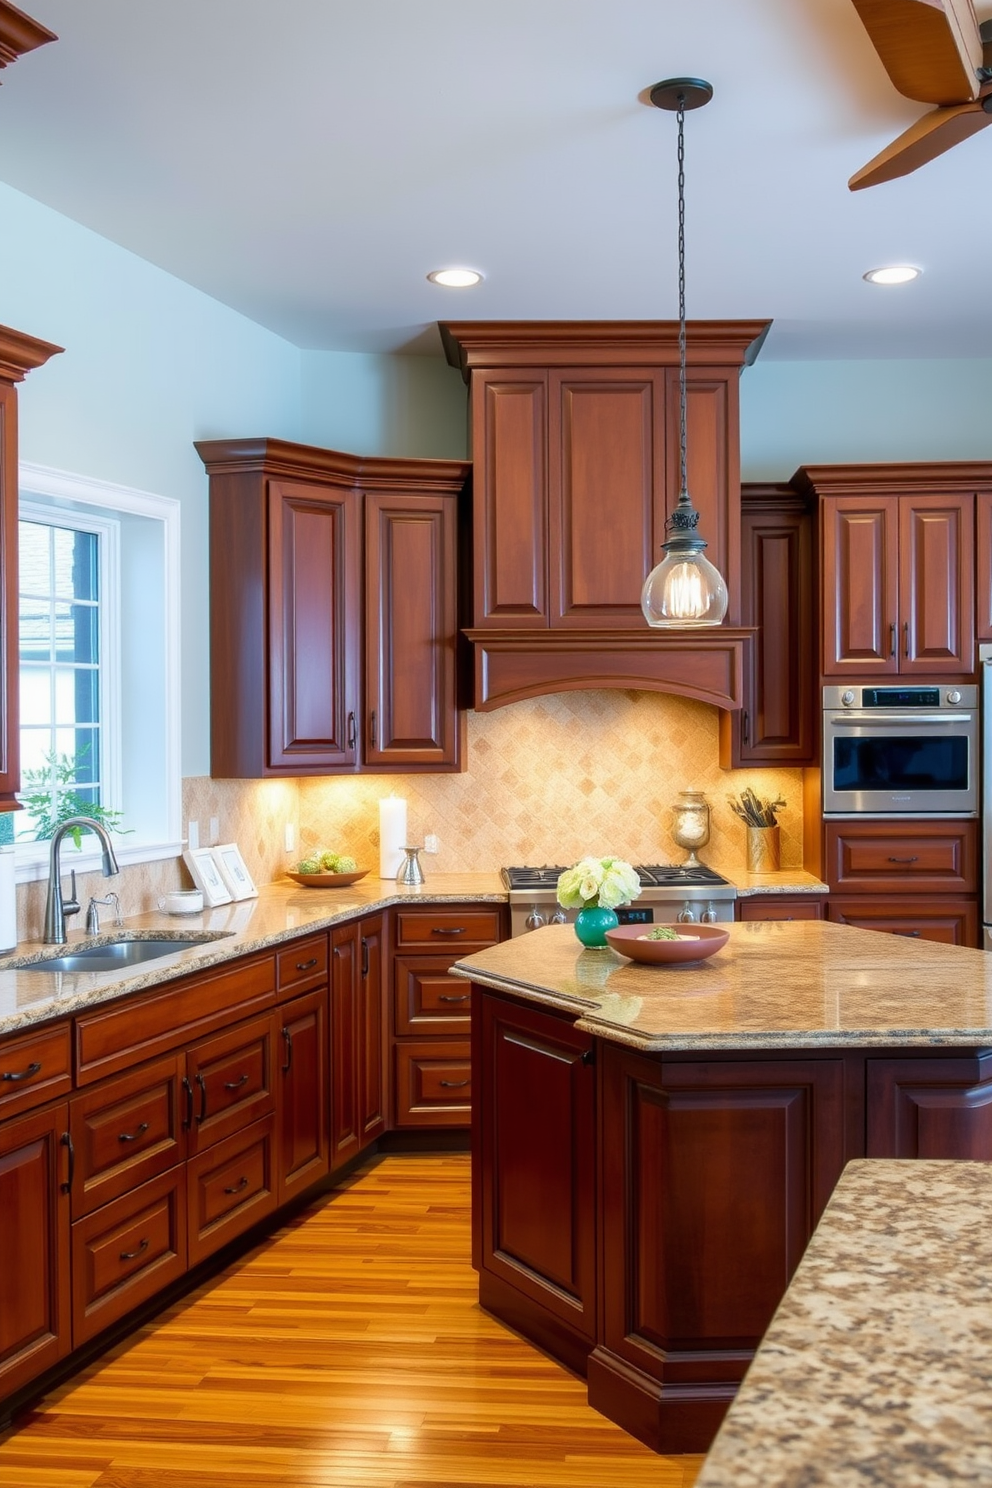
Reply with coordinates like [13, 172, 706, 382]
[330, 915, 385, 1173]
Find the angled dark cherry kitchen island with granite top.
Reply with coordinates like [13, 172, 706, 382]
[455, 921, 992, 1452]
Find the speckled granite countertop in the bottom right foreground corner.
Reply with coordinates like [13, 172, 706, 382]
[696, 1159, 992, 1488]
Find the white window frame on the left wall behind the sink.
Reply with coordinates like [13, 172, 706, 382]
[16, 461, 183, 882]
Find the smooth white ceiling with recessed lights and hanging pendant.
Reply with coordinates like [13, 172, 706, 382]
[0, 0, 992, 360]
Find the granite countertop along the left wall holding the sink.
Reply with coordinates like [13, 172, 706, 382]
[0, 873, 507, 1036]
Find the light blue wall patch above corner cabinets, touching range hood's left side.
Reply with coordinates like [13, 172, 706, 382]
[302, 351, 468, 460]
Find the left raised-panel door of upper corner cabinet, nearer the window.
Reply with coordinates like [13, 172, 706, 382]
[266, 481, 361, 774]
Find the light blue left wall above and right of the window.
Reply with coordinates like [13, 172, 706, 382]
[0, 185, 300, 775]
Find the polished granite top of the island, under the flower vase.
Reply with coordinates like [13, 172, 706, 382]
[452, 920, 992, 1051]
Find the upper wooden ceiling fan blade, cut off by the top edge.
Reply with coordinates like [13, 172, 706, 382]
[854, 0, 983, 104]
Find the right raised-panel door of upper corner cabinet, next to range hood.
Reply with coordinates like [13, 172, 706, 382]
[363, 494, 460, 769]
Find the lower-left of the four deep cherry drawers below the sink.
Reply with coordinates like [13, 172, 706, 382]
[71, 1165, 186, 1348]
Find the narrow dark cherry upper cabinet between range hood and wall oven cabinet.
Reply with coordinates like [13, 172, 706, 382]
[720, 485, 818, 769]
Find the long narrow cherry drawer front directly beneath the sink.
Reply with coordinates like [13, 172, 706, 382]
[76, 955, 275, 1085]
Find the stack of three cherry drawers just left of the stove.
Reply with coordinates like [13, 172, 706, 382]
[390, 905, 506, 1128]
